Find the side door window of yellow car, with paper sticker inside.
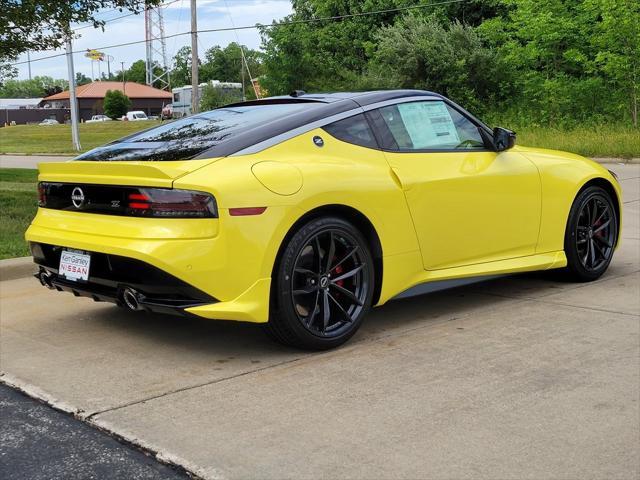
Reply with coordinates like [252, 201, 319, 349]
[379, 101, 484, 150]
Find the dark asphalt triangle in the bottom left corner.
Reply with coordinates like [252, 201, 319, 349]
[0, 385, 189, 480]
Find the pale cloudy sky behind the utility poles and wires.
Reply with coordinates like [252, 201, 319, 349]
[17, 0, 291, 80]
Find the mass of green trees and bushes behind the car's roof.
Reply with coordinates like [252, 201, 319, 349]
[261, 0, 640, 127]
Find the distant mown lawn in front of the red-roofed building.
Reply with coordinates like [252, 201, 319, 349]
[0, 120, 160, 155]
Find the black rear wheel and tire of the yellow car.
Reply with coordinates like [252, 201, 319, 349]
[266, 217, 375, 350]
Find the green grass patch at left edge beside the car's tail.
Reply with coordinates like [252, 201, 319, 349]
[0, 168, 38, 259]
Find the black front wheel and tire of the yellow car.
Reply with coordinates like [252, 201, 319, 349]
[564, 186, 619, 282]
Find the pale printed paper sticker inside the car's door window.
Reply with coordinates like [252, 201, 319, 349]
[398, 102, 460, 149]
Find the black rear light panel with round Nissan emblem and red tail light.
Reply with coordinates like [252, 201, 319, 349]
[38, 182, 218, 218]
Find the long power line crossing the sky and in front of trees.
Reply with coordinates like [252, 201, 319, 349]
[9, 0, 468, 66]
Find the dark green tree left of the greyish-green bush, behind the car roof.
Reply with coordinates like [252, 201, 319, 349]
[261, 0, 408, 94]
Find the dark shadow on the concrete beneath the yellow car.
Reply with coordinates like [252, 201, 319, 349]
[84, 272, 570, 356]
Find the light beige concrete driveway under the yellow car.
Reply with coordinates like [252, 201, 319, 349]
[0, 165, 640, 479]
